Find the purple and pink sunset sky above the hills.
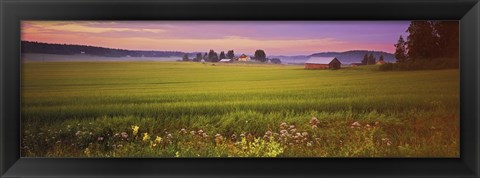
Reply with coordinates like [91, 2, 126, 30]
[21, 21, 410, 55]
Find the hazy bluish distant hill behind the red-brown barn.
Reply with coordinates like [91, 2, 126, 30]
[269, 50, 396, 64]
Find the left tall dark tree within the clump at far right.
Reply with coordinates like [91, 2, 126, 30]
[407, 21, 438, 60]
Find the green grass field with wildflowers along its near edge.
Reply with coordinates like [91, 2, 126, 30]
[21, 62, 459, 157]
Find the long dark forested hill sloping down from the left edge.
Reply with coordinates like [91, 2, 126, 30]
[21, 41, 185, 57]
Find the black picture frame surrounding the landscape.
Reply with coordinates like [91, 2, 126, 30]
[0, 0, 480, 177]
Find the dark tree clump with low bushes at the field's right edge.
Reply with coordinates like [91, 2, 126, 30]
[381, 21, 460, 70]
